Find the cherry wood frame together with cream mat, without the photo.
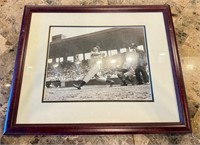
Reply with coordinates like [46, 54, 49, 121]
[4, 5, 191, 135]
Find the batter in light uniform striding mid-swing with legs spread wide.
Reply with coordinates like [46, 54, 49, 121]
[73, 46, 114, 89]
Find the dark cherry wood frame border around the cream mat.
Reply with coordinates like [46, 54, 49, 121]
[4, 5, 191, 135]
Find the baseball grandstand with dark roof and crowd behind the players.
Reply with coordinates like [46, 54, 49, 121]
[46, 26, 146, 87]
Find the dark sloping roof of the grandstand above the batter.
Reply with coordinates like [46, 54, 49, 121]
[49, 27, 145, 58]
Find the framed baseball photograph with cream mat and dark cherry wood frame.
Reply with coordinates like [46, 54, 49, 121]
[4, 5, 191, 134]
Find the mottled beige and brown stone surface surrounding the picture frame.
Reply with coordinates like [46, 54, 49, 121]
[0, 0, 200, 145]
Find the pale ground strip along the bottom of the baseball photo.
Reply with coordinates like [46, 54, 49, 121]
[43, 85, 152, 101]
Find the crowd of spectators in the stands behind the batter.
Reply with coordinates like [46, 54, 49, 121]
[46, 54, 120, 81]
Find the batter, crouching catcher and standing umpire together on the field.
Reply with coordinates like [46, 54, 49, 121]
[73, 43, 149, 89]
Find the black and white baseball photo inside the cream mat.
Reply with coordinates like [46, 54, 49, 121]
[42, 26, 154, 103]
